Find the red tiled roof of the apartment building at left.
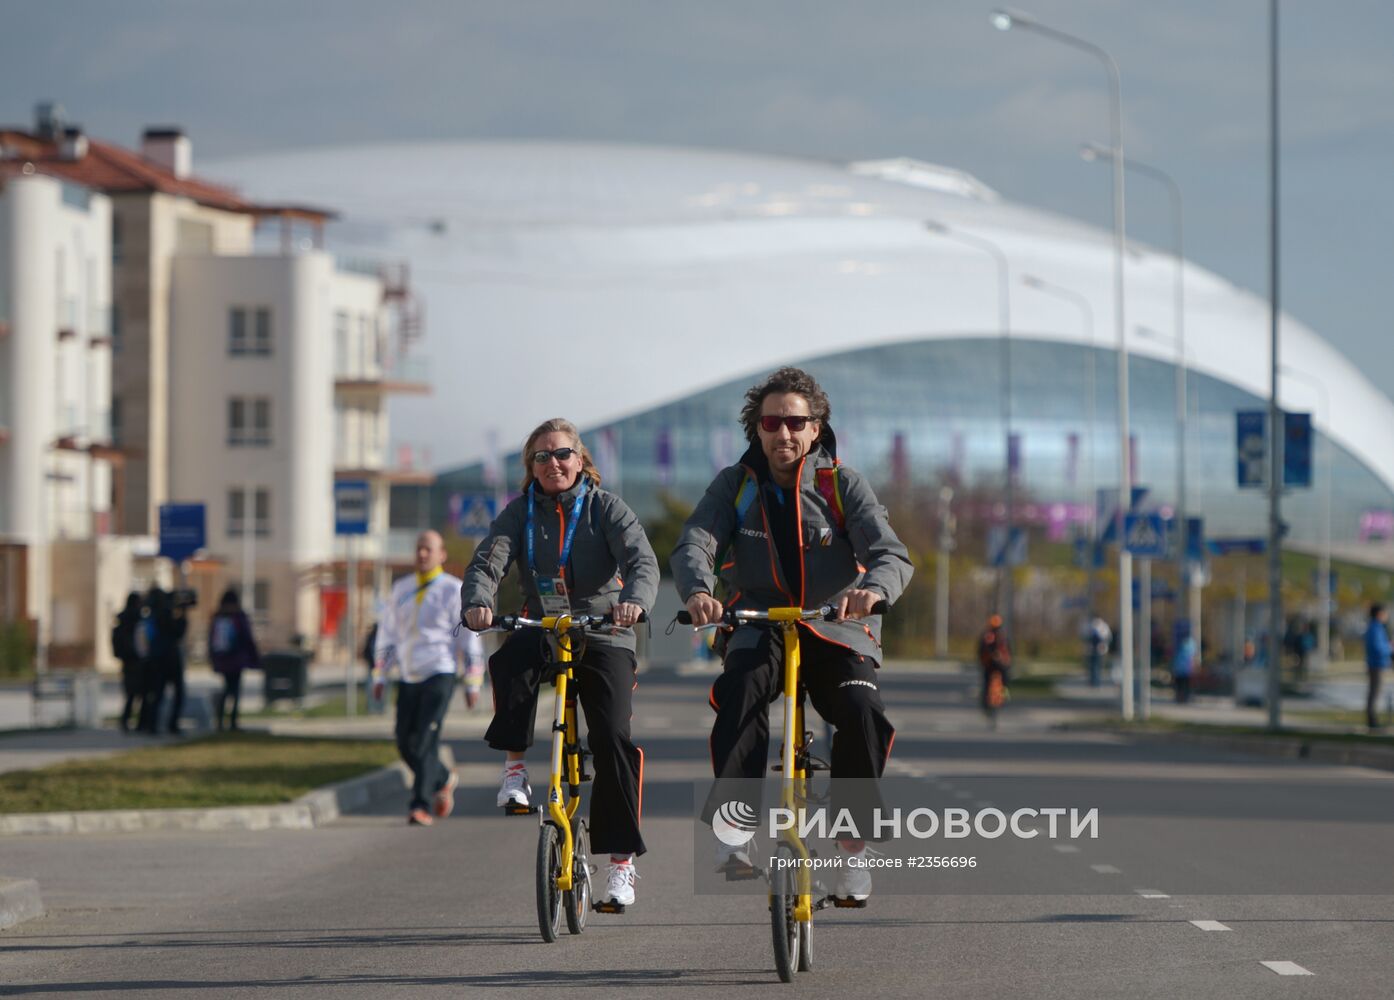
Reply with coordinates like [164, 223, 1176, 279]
[0, 128, 328, 216]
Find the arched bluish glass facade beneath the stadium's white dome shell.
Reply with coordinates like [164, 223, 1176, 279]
[431, 338, 1394, 545]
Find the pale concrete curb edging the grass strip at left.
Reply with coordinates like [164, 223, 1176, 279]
[0, 745, 454, 836]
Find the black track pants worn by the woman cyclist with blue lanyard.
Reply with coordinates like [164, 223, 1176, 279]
[484, 632, 647, 855]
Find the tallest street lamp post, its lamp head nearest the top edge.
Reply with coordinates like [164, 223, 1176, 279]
[991, 8, 1133, 720]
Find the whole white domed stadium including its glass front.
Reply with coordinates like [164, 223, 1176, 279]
[210, 142, 1394, 543]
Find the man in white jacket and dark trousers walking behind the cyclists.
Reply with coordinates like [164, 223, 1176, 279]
[372, 531, 480, 827]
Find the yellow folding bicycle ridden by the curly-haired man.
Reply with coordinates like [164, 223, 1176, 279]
[677, 601, 887, 983]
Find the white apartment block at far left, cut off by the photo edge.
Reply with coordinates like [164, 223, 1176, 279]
[0, 158, 130, 664]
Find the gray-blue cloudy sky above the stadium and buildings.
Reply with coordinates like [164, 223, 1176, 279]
[0, 0, 1394, 384]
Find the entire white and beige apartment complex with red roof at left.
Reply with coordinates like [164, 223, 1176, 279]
[0, 105, 429, 665]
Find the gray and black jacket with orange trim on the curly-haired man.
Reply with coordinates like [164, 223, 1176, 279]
[669, 428, 914, 662]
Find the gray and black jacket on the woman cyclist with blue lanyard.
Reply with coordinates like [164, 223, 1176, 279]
[460, 480, 658, 651]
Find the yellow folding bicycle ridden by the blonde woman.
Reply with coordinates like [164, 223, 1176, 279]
[482, 615, 643, 943]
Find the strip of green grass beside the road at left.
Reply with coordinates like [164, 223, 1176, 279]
[0, 732, 396, 813]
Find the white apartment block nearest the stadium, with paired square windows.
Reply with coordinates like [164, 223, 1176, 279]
[170, 250, 427, 642]
